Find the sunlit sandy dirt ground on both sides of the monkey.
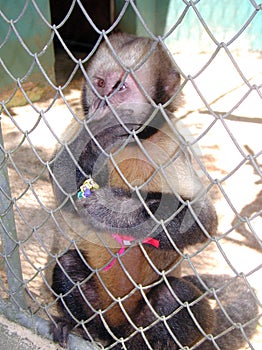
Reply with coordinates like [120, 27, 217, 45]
[0, 47, 262, 350]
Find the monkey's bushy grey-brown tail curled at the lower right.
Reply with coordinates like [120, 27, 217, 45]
[184, 274, 258, 350]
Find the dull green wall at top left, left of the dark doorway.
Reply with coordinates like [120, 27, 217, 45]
[0, 0, 54, 95]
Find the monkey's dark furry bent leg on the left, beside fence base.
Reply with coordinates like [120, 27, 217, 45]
[52, 250, 109, 347]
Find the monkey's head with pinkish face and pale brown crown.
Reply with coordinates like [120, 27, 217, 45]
[82, 34, 181, 119]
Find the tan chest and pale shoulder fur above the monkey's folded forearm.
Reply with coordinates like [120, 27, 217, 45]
[109, 125, 201, 199]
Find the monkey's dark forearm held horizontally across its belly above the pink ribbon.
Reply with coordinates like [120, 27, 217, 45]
[76, 187, 217, 249]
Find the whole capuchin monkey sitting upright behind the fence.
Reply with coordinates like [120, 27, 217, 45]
[51, 34, 257, 350]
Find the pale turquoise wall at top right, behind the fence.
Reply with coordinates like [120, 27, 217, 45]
[116, 0, 262, 51]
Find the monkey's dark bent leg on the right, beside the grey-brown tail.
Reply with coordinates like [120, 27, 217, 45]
[116, 277, 215, 350]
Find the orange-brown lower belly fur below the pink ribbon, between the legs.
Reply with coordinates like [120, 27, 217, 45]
[83, 241, 179, 327]
